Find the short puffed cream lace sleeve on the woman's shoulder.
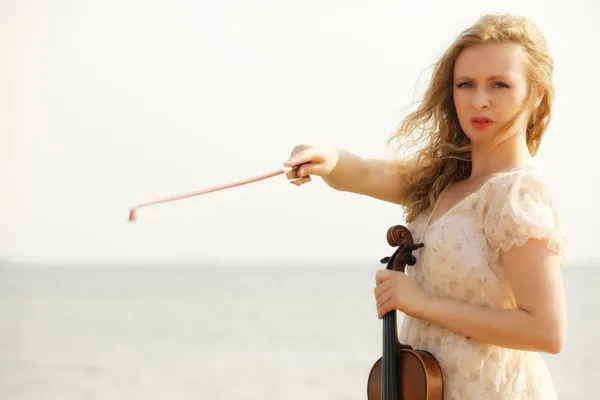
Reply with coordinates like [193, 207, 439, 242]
[483, 173, 571, 268]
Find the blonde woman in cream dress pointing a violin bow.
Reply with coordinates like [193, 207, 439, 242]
[284, 15, 570, 400]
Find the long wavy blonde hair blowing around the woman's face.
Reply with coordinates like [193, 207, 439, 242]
[387, 14, 554, 222]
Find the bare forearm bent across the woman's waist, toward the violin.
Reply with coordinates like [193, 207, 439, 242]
[418, 297, 562, 353]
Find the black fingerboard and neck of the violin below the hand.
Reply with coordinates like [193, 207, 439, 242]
[381, 304, 400, 400]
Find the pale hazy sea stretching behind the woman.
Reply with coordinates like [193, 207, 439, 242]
[0, 262, 600, 400]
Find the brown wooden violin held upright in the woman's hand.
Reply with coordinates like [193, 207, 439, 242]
[367, 225, 443, 400]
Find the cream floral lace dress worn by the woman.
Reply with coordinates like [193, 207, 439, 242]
[399, 164, 570, 400]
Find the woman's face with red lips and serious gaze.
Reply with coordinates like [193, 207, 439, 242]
[453, 43, 529, 144]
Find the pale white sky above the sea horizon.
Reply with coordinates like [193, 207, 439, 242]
[0, 0, 600, 266]
